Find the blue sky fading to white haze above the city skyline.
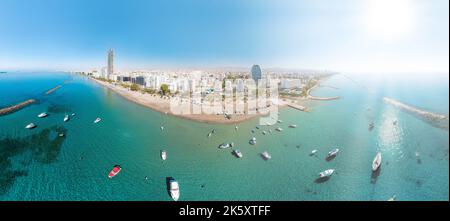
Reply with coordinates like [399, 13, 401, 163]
[0, 0, 449, 73]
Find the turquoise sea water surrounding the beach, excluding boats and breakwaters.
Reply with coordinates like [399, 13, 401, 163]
[0, 73, 449, 201]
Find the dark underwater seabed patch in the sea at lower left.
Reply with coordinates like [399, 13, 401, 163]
[0, 126, 67, 195]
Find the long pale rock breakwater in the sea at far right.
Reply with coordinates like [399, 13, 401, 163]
[383, 97, 449, 131]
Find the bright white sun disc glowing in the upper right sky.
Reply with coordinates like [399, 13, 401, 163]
[363, 0, 414, 38]
